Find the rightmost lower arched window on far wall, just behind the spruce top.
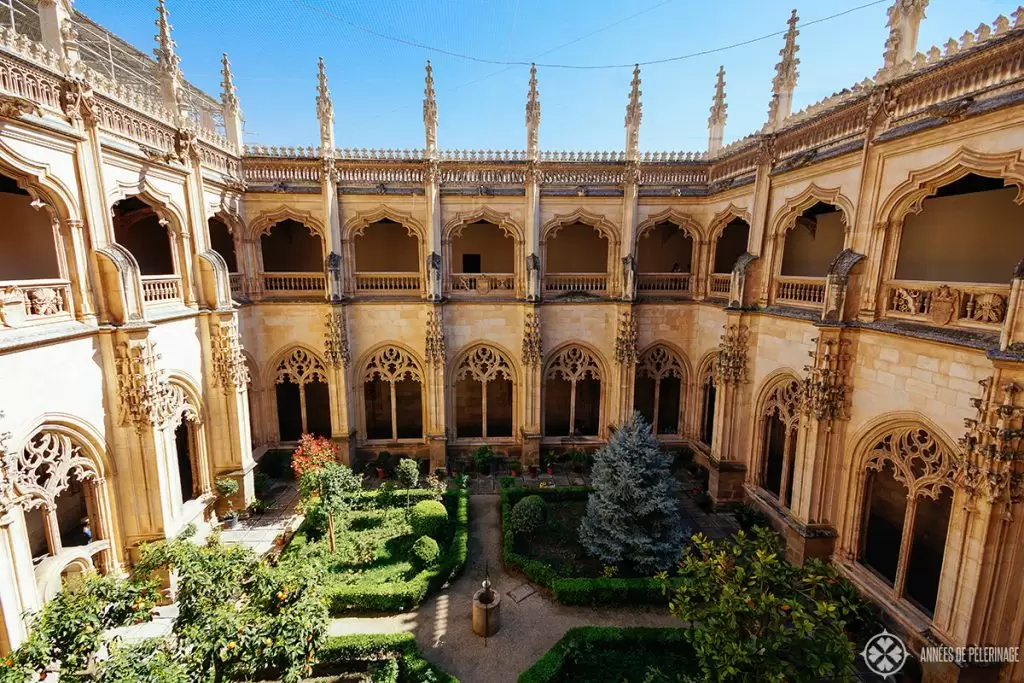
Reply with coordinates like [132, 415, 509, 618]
[633, 344, 686, 434]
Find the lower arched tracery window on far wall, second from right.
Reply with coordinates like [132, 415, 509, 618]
[544, 344, 601, 436]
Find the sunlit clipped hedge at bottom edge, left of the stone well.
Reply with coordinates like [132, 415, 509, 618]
[318, 633, 459, 683]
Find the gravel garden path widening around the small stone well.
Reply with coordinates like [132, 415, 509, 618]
[331, 495, 681, 683]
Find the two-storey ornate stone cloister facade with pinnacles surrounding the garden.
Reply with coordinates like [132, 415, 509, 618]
[0, 0, 1024, 681]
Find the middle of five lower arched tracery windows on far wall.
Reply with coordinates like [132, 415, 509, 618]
[455, 346, 515, 438]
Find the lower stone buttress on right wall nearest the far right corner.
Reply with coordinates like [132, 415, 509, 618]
[709, 317, 750, 504]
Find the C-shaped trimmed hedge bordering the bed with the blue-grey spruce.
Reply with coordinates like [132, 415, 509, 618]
[502, 486, 669, 605]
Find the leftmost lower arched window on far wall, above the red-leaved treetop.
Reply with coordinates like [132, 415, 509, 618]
[272, 346, 331, 441]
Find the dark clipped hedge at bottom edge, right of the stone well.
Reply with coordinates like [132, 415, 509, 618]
[519, 626, 690, 683]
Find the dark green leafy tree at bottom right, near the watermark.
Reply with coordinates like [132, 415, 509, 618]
[669, 528, 869, 683]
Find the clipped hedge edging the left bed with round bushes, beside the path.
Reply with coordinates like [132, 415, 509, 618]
[327, 489, 469, 616]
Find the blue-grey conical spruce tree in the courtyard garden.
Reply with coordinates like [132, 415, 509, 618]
[580, 413, 686, 573]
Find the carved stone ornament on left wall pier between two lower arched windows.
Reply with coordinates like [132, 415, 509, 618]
[117, 339, 199, 430]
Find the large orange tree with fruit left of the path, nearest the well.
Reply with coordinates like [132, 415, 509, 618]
[136, 527, 328, 683]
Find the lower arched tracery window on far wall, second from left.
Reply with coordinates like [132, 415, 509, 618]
[362, 346, 423, 441]
